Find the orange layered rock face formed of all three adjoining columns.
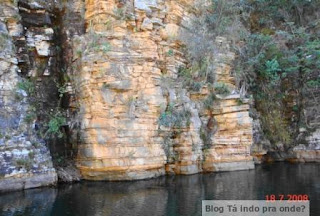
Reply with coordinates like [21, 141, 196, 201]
[72, 0, 253, 180]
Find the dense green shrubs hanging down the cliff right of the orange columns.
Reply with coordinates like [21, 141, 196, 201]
[237, 0, 320, 145]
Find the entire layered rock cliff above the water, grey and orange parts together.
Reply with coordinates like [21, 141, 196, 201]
[0, 0, 320, 191]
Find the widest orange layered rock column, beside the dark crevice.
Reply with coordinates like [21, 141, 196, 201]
[73, 0, 166, 180]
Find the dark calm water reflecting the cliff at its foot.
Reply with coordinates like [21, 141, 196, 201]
[0, 163, 320, 216]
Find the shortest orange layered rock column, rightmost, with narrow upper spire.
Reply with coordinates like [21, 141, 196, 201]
[203, 37, 254, 171]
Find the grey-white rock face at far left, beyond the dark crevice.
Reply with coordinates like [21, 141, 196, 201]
[0, 0, 57, 191]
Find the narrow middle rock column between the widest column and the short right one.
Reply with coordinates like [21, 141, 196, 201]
[160, 0, 203, 175]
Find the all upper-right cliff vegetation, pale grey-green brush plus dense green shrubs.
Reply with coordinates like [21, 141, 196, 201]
[186, 0, 320, 147]
